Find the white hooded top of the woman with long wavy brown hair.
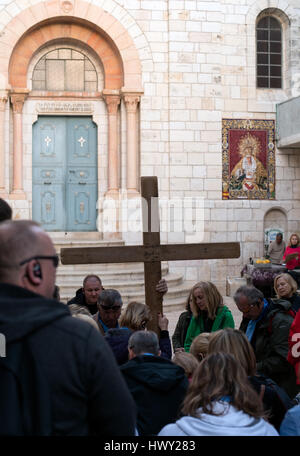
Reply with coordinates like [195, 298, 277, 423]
[158, 401, 278, 437]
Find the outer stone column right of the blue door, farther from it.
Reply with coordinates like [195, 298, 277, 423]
[124, 93, 140, 195]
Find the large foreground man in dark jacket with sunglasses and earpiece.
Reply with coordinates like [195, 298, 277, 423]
[0, 220, 135, 436]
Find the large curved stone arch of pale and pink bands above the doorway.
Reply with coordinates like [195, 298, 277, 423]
[0, 0, 142, 92]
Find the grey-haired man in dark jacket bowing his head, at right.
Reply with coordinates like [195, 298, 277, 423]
[234, 286, 297, 398]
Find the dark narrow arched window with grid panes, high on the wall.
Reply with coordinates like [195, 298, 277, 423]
[256, 16, 282, 89]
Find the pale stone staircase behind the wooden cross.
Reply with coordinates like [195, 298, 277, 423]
[49, 233, 194, 312]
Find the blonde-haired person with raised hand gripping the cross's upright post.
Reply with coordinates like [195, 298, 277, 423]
[105, 301, 172, 365]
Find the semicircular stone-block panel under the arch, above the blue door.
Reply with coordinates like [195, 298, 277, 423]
[32, 48, 97, 92]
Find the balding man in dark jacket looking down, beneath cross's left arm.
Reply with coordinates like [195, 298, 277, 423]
[67, 274, 104, 315]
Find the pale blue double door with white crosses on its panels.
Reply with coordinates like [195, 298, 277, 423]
[32, 116, 97, 231]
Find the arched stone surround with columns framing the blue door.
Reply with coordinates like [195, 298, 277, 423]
[0, 5, 143, 233]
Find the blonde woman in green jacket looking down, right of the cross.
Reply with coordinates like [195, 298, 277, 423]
[184, 282, 234, 352]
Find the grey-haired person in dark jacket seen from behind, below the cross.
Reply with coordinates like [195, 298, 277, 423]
[121, 331, 188, 435]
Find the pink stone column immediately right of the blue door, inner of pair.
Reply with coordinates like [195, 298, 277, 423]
[104, 95, 121, 195]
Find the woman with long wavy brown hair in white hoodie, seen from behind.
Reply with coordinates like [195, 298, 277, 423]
[158, 352, 278, 436]
